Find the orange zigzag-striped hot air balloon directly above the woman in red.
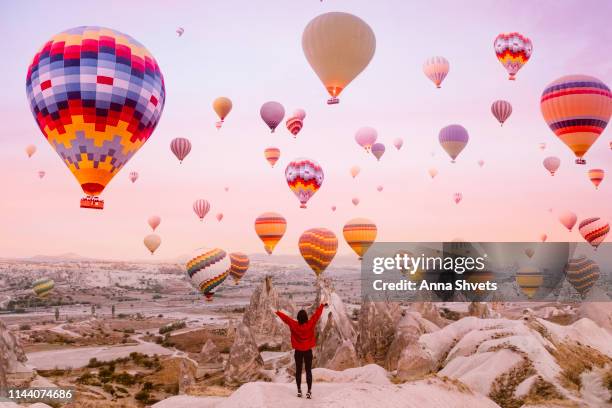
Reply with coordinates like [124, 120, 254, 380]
[298, 228, 338, 277]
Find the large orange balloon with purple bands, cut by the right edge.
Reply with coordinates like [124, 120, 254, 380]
[540, 75, 612, 164]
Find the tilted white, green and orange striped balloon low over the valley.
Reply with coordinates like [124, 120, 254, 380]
[186, 248, 231, 302]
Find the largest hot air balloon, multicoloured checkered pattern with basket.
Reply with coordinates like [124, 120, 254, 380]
[26, 26, 166, 209]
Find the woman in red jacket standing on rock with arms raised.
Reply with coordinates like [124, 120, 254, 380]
[275, 303, 327, 398]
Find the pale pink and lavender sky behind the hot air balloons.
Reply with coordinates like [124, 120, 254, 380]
[0, 0, 612, 260]
